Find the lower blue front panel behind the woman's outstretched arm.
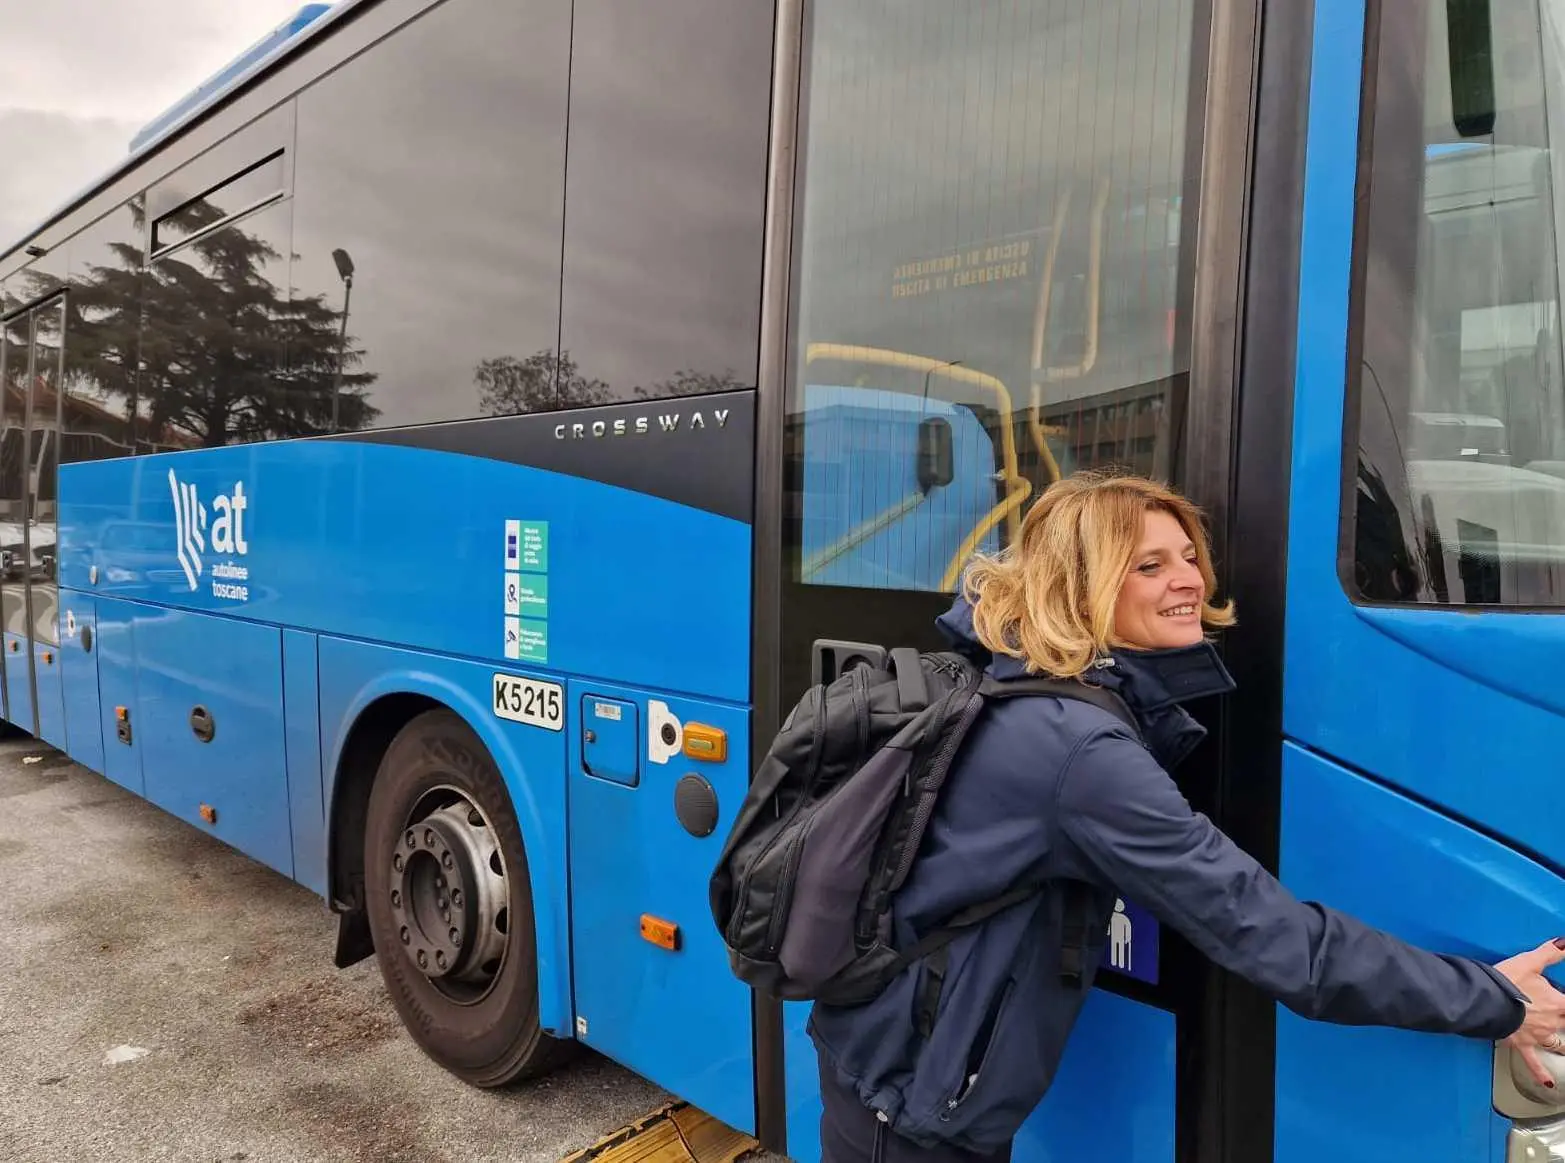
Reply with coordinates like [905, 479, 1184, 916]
[1275, 744, 1565, 1163]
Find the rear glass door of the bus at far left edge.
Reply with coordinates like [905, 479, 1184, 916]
[0, 297, 66, 748]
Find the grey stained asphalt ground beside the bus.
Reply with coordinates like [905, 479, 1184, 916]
[0, 740, 667, 1163]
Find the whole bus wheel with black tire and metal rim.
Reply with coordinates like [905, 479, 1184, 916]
[365, 708, 571, 1088]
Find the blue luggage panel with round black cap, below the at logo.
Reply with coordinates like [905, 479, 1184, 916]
[136, 606, 293, 877]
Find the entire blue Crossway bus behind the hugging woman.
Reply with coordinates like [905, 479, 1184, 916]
[0, 0, 1565, 1163]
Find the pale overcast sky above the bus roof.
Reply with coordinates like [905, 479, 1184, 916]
[0, 0, 304, 249]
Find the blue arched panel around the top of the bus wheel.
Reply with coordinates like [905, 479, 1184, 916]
[319, 636, 576, 1038]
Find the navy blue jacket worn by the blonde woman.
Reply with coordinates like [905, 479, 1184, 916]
[811, 598, 1524, 1150]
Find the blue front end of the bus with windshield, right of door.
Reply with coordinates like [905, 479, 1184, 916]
[1275, 0, 1565, 1163]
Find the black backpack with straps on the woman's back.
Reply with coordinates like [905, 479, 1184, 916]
[709, 650, 1141, 1005]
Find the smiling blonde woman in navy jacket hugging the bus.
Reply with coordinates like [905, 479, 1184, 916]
[801, 473, 1565, 1163]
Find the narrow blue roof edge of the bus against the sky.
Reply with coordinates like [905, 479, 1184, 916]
[0, 0, 372, 260]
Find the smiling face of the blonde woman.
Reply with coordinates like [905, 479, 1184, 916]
[1114, 509, 1207, 650]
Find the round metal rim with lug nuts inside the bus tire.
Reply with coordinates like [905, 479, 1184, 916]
[385, 787, 510, 1005]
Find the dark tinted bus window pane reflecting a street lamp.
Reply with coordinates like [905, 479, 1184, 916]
[288, 0, 570, 430]
